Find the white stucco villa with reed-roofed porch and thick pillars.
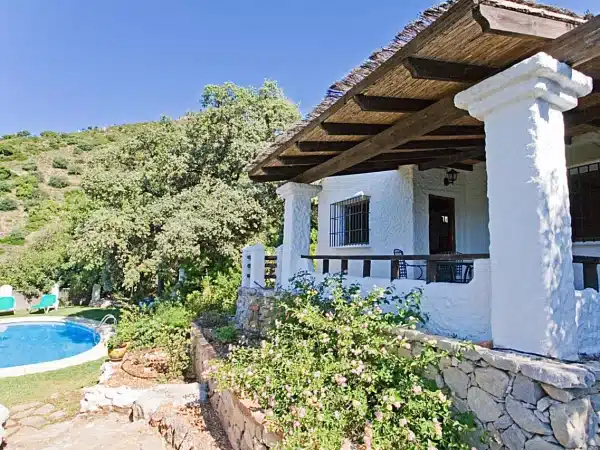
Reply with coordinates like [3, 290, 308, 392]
[243, 0, 600, 359]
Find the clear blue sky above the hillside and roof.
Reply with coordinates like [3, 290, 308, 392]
[0, 0, 600, 134]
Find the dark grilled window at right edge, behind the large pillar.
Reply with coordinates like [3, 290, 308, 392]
[569, 163, 600, 241]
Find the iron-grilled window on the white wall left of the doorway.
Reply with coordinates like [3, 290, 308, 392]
[329, 195, 369, 247]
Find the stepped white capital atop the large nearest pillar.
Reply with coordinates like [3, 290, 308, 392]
[454, 53, 592, 120]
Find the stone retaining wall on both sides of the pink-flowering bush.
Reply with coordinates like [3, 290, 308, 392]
[193, 318, 600, 450]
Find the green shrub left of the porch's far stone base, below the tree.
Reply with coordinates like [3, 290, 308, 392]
[185, 268, 242, 315]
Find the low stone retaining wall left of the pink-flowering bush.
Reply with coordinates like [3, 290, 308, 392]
[192, 324, 281, 450]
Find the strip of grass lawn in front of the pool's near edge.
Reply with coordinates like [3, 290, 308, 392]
[0, 359, 104, 415]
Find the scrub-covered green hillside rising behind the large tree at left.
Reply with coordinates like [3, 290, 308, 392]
[0, 124, 146, 262]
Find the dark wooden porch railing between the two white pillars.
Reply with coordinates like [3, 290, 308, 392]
[302, 253, 490, 283]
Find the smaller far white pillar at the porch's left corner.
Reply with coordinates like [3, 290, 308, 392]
[277, 183, 321, 289]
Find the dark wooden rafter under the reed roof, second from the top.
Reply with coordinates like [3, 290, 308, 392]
[404, 56, 499, 83]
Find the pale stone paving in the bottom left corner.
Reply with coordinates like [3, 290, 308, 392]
[9, 412, 168, 450]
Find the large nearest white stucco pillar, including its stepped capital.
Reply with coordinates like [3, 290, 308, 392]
[455, 53, 592, 359]
